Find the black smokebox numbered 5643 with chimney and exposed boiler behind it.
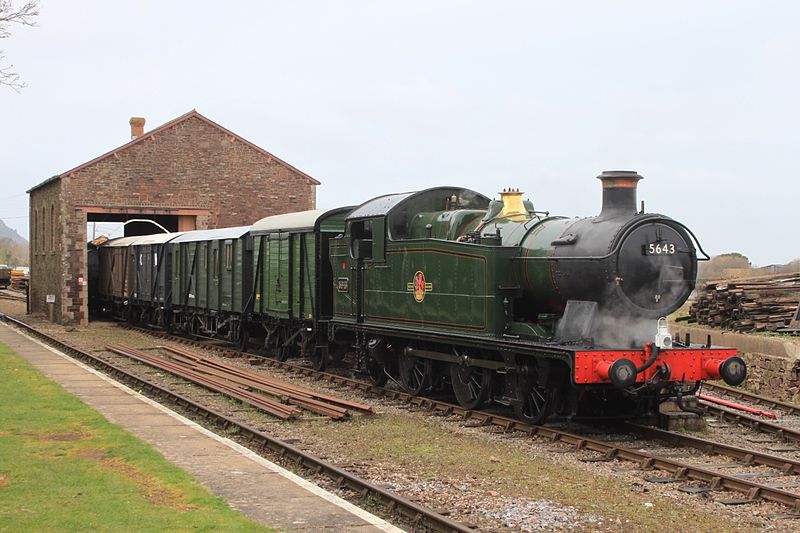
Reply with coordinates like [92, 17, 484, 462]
[516, 170, 697, 324]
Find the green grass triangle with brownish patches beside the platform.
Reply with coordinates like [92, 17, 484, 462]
[0, 344, 265, 532]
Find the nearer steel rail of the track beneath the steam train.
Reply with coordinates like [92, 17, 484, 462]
[117, 326, 800, 513]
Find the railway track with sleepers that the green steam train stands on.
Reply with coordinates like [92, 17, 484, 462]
[117, 325, 800, 516]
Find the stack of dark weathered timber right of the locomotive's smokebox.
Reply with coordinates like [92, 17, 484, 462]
[688, 273, 800, 333]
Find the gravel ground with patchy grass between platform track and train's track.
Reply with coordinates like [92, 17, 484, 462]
[0, 304, 800, 532]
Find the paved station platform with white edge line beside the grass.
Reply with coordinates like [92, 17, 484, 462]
[0, 323, 403, 533]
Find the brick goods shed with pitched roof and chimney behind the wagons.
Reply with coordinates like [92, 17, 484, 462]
[28, 110, 319, 324]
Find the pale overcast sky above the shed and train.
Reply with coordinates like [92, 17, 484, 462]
[0, 0, 800, 266]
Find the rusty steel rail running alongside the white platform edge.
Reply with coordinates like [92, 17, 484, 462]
[0, 313, 474, 533]
